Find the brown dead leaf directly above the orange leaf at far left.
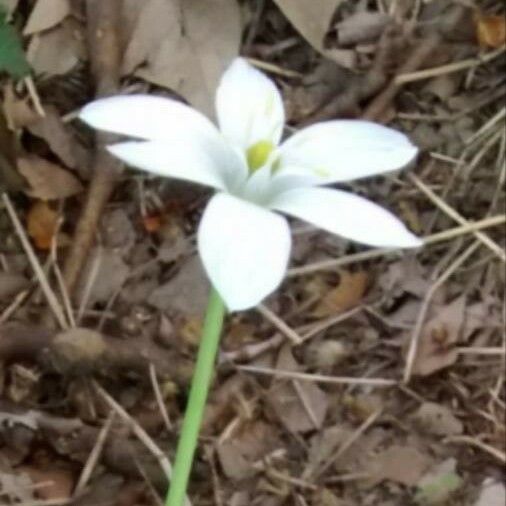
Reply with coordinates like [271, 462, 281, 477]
[18, 155, 83, 200]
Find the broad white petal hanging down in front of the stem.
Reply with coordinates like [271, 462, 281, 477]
[198, 193, 291, 311]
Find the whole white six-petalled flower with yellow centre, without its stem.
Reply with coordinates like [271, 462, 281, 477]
[80, 58, 421, 310]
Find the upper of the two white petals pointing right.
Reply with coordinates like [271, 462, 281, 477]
[278, 120, 417, 184]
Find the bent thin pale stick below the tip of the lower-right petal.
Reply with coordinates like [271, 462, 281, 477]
[403, 241, 480, 383]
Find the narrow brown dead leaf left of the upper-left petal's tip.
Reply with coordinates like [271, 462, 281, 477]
[28, 106, 90, 175]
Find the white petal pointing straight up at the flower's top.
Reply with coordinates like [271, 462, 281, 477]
[216, 58, 285, 150]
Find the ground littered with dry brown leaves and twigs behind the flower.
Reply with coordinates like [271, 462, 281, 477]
[0, 0, 506, 506]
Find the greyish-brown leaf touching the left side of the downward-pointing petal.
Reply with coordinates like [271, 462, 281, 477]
[148, 256, 209, 317]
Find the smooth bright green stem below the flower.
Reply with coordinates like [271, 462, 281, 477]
[165, 289, 225, 506]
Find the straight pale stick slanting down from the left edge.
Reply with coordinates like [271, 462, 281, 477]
[2, 193, 69, 329]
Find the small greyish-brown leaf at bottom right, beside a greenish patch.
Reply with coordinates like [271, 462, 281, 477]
[368, 445, 431, 487]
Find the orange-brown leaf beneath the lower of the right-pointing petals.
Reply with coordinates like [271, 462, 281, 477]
[314, 271, 369, 318]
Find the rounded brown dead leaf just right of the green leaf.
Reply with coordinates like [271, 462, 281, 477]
[26, 18, 87, 77]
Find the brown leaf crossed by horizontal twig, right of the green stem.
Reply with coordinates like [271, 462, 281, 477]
[267, 347, 329, 432]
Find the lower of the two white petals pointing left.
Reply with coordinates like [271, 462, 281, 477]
[107, 141, 247, 190]
